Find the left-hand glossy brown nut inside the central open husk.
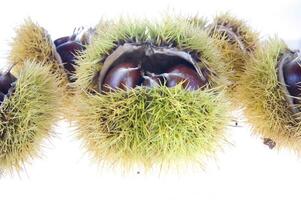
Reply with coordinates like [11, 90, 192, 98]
[99, 63, 142, 92]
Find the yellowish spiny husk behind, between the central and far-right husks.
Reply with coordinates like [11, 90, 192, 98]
[209, 13, 260, 105]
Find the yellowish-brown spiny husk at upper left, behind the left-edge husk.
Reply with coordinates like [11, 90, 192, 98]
[9, 19, 74, 119]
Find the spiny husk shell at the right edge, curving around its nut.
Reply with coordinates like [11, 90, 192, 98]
[238, 38, 301, 152]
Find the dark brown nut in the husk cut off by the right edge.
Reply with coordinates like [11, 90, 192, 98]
[283, 59, 301, 97]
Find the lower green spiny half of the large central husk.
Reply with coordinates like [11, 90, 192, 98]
[77, 85, 227, 168]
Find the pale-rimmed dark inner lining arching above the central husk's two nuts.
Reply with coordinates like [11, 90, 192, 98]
[98, 43, 207, 91]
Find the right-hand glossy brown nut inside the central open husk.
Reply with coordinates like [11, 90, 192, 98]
[164, 64, 206, 91]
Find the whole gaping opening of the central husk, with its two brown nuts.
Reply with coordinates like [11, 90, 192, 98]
[98, 44, 207, 92]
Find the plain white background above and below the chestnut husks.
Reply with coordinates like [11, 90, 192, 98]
[0, 0, 301, 200]
